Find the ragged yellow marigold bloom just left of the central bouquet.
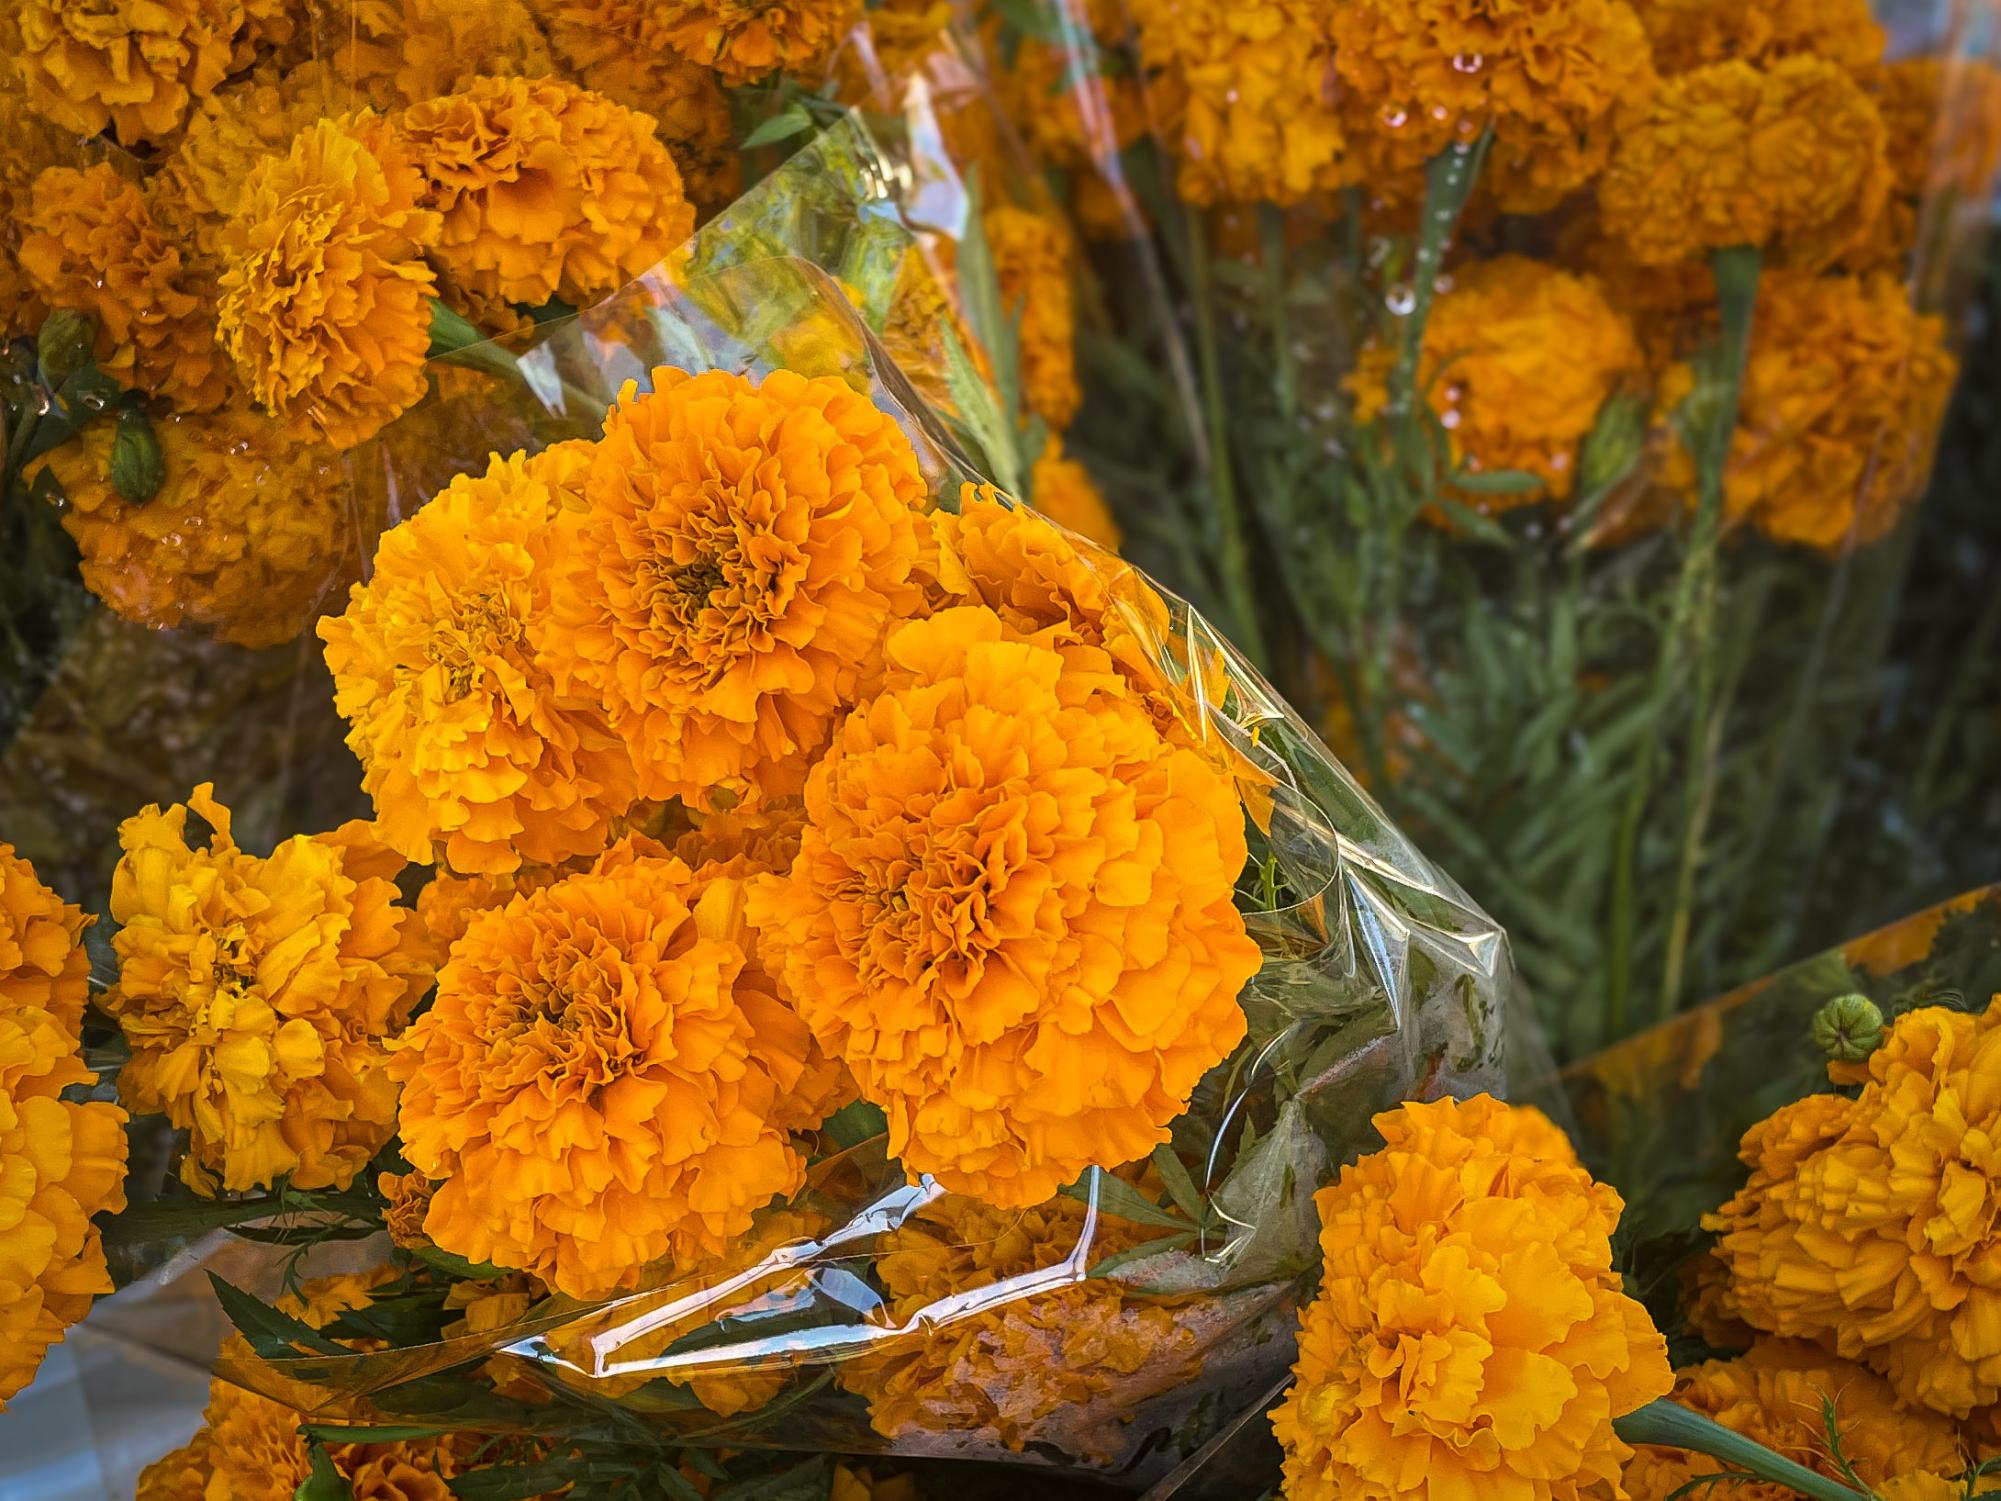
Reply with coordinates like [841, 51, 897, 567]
[102, 783, 430, 1195]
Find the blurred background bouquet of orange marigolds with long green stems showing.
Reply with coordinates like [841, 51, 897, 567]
[948, 0, 2001, 1055]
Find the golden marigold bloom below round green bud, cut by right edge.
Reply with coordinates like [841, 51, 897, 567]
[1703, 1005, 2001, 1424]
